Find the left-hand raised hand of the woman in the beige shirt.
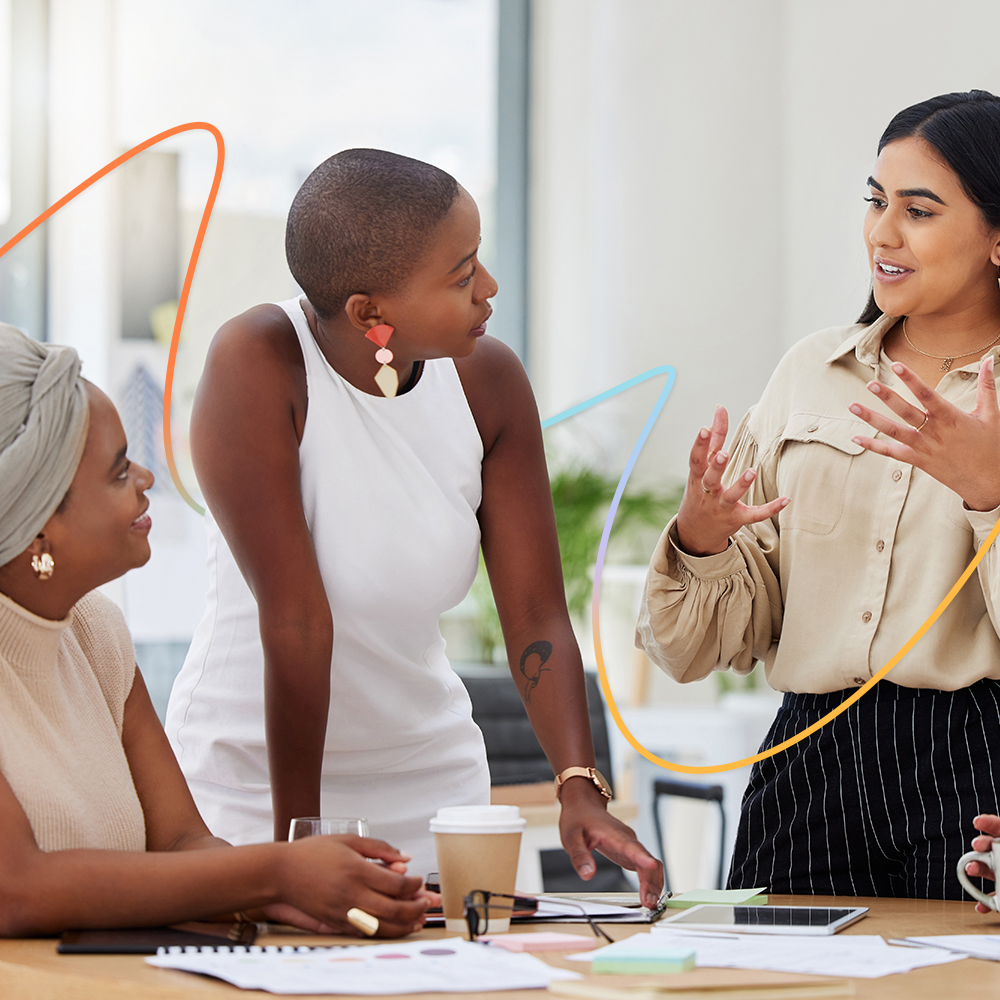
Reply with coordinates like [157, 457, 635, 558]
[677, 406, 788, 556]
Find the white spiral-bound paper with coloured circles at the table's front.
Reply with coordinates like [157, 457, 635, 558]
[146, 938, 582, 995]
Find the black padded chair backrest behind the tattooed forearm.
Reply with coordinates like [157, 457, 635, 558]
[455, 664, 611, 785]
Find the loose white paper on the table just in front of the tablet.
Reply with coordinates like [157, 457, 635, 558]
[569, 927, 965, 979]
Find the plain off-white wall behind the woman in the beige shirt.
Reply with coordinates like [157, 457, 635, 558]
[530, 0, 1000, 479]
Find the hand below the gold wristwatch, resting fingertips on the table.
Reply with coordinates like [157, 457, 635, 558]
[559, 779, 663, 910]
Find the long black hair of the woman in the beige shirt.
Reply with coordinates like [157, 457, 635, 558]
[858, 90, 1000, 323]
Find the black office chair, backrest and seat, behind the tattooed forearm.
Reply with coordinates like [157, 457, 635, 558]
[455, 664, 633, 892]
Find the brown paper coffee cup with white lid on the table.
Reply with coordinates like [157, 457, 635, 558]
[431, 806, 527, 934]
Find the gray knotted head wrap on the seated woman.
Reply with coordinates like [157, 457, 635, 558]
[0, 323, 90, 566]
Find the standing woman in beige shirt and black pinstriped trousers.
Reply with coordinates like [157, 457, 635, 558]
[637, 91, 1000, 898]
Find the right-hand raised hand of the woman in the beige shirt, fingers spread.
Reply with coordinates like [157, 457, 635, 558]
[850, 355, 1000, 510]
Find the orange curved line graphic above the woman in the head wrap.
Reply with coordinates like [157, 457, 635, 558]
[0, 122, 226, 514]
